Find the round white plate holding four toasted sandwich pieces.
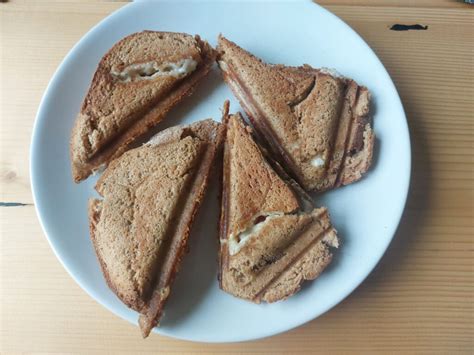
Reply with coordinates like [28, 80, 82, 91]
[31, 2, 410, 342]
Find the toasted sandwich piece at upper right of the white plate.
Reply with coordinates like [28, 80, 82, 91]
[217, 36, 374, 191]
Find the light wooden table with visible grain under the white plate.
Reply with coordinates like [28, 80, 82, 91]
[0, 0, 474, 353]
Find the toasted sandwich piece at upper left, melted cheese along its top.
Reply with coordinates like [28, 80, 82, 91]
[70, 31, 215, 182]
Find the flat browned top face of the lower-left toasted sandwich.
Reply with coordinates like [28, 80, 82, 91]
[94, 137, 203, 311]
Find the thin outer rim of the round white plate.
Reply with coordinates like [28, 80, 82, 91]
[29, 0, 412, 343]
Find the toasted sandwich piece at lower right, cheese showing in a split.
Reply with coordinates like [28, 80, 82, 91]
[219, 104, 339, 303]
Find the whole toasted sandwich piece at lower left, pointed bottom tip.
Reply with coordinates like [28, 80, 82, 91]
[89, 120, 224, 337]
